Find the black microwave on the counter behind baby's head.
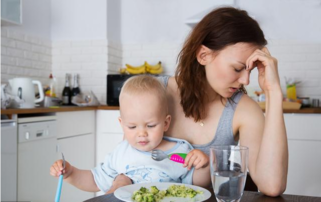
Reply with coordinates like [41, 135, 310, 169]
[106, 74, 135, 106]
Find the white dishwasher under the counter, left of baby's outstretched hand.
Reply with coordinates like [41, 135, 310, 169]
[18, 115, 58, 202]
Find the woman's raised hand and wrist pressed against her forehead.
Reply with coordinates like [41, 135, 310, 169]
[246, 47, 281, 93]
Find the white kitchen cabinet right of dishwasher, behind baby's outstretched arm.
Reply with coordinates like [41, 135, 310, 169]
[57, 110, 96, 202]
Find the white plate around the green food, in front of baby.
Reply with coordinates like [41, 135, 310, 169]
[114, 182, 211, 202]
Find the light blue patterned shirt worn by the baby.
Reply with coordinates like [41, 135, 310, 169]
[91, 137, 194, 192]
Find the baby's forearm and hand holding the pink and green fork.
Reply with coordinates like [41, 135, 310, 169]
[184, 149, 211, 187]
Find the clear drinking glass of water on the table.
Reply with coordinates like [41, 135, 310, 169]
[210, 145, 249, 202]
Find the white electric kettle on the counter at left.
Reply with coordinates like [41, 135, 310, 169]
[9, 78, 44, 108]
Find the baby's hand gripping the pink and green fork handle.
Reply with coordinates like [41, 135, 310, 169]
[184, 149, 209, 170]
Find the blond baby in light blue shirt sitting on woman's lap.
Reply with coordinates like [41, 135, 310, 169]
[50, 75, 210, 193]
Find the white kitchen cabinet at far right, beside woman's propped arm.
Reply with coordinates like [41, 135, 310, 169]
[284, 114, 321, 197]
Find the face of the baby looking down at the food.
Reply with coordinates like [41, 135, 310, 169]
[119, 93, 170, 151]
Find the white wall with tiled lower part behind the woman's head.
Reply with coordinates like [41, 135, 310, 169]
[121, 0, 321, 99]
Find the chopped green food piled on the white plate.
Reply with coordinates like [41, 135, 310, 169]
[132, 185, 203, 202]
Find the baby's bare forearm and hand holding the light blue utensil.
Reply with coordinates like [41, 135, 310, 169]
[50, 160, 99, 192]
